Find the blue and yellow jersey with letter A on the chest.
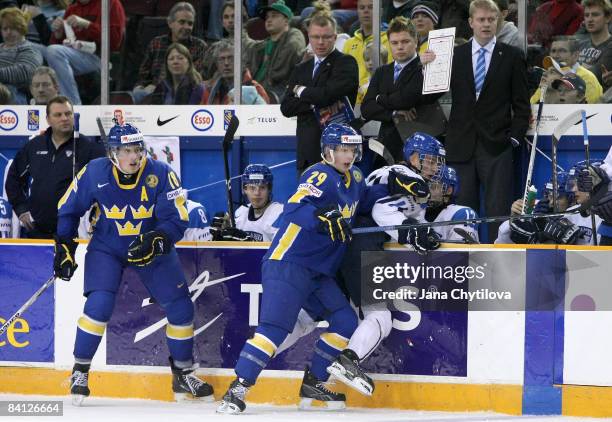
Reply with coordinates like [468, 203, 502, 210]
[57, 158, 189, 258]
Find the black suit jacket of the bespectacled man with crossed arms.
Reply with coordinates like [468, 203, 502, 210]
[281, 50, 359, 171]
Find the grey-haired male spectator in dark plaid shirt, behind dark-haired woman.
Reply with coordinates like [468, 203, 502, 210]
[132, 2, 207, 104]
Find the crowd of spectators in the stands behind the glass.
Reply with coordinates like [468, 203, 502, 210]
[0, 0, 612, 104]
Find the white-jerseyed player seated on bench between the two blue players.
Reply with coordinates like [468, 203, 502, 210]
[211, 164, 283, 242]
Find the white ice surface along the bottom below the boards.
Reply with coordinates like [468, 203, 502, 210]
[0, 394, 609, 422]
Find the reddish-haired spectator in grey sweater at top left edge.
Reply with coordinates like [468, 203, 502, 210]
[0, 7, 42, 104]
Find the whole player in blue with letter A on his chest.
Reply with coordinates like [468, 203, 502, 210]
[54, 125, 213, 405]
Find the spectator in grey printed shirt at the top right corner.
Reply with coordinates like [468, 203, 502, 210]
[578, 0, 612, 90]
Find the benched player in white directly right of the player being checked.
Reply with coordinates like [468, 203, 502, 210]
[425, 166, 478, 242]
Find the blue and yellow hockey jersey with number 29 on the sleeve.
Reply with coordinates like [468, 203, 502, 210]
[263, 162, 387, 277]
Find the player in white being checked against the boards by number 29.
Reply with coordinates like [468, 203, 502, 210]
[327, 132, 446, 395]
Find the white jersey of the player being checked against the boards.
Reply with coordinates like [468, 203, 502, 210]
[366, 164, 425, 241]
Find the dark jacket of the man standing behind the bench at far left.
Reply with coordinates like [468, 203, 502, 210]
[5, 128, 105, 237]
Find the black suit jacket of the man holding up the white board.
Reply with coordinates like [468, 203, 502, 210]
[361, 56, 442, 165]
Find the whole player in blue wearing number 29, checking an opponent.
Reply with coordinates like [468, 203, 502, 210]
[217, 124, 416, 414]
